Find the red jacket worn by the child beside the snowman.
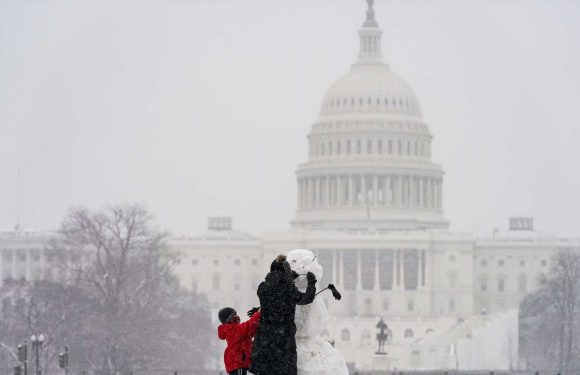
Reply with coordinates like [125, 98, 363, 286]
[218, 311, 260, 373]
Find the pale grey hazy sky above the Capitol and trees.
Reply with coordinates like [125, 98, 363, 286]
[0, 0, 580, 236]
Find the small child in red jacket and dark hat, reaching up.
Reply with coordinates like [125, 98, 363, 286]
[218, 307, 260, 375]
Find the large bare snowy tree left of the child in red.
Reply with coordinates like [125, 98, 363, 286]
[52, 204, 209, 375]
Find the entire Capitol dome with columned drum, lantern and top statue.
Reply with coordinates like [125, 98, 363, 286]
[291, 0, 448, 231]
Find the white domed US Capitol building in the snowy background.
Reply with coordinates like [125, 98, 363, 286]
[0, 1, 580, 370]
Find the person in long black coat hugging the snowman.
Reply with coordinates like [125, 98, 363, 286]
[250, 255, 316, 375]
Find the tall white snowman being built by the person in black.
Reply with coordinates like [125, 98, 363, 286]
[286, 249, 348, 375]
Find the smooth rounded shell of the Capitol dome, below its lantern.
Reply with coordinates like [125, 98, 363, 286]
[320, 63, 421, 118]
